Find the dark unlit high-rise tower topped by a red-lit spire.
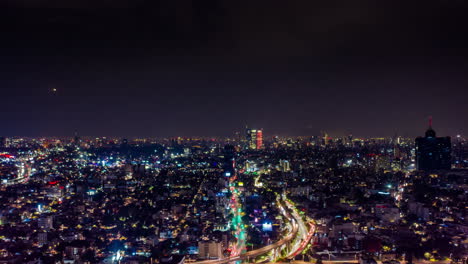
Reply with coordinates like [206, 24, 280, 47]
[416, 119, 452, 171]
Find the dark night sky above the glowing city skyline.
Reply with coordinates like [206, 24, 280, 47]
[0, 0, 468, 137]
